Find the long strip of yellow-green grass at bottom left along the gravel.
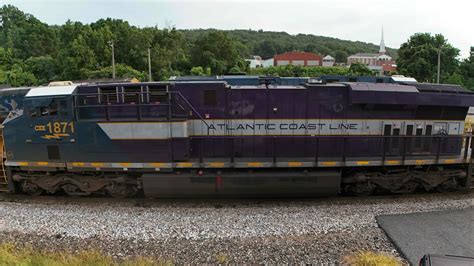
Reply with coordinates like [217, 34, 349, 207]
[0, 244, 172, 266]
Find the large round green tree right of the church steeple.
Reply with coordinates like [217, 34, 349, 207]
[397, 33, 459, 82]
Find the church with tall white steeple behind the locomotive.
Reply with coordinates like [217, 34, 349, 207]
[347, 29, 397, 74]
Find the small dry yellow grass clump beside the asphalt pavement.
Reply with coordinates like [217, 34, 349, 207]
[342, 251, 406, 266]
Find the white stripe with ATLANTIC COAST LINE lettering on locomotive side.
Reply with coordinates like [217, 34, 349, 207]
[98, 119, 464, 139]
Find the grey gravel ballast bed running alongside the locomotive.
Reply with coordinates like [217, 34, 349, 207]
[0, 192, 474, 263]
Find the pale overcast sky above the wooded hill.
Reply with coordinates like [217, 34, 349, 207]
[0, 0, 474, 58]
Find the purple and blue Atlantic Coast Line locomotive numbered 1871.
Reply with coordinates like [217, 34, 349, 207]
[3, 81, 474, 197]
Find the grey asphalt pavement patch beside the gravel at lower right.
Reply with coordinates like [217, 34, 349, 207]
[377, 208, 474, 265]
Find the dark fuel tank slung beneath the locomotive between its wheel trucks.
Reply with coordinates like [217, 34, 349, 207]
[142, 170, 341, 198]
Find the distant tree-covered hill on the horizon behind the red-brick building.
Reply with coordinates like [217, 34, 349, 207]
[179, 29, 397, 61]
